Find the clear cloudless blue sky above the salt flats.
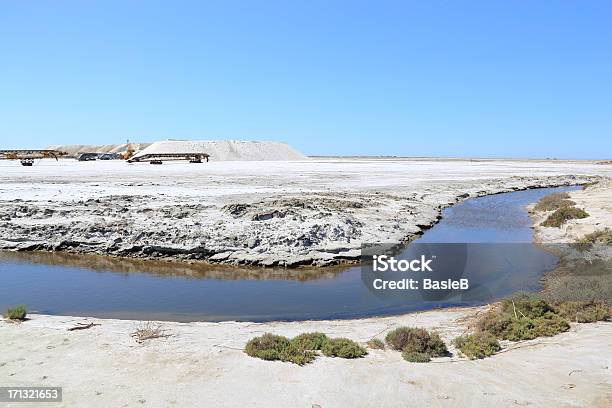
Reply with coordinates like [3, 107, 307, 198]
[0, 0, 612, 159]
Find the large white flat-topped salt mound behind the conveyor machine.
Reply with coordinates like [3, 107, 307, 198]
[134, 140, 306, 161]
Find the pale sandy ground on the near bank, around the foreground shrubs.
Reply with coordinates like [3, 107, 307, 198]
[0, 164, 612, 408]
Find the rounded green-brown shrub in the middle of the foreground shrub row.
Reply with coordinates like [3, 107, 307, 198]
[385, 327, 448, 357]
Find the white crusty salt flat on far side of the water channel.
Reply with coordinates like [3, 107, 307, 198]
[0, 158, 612, 266]
